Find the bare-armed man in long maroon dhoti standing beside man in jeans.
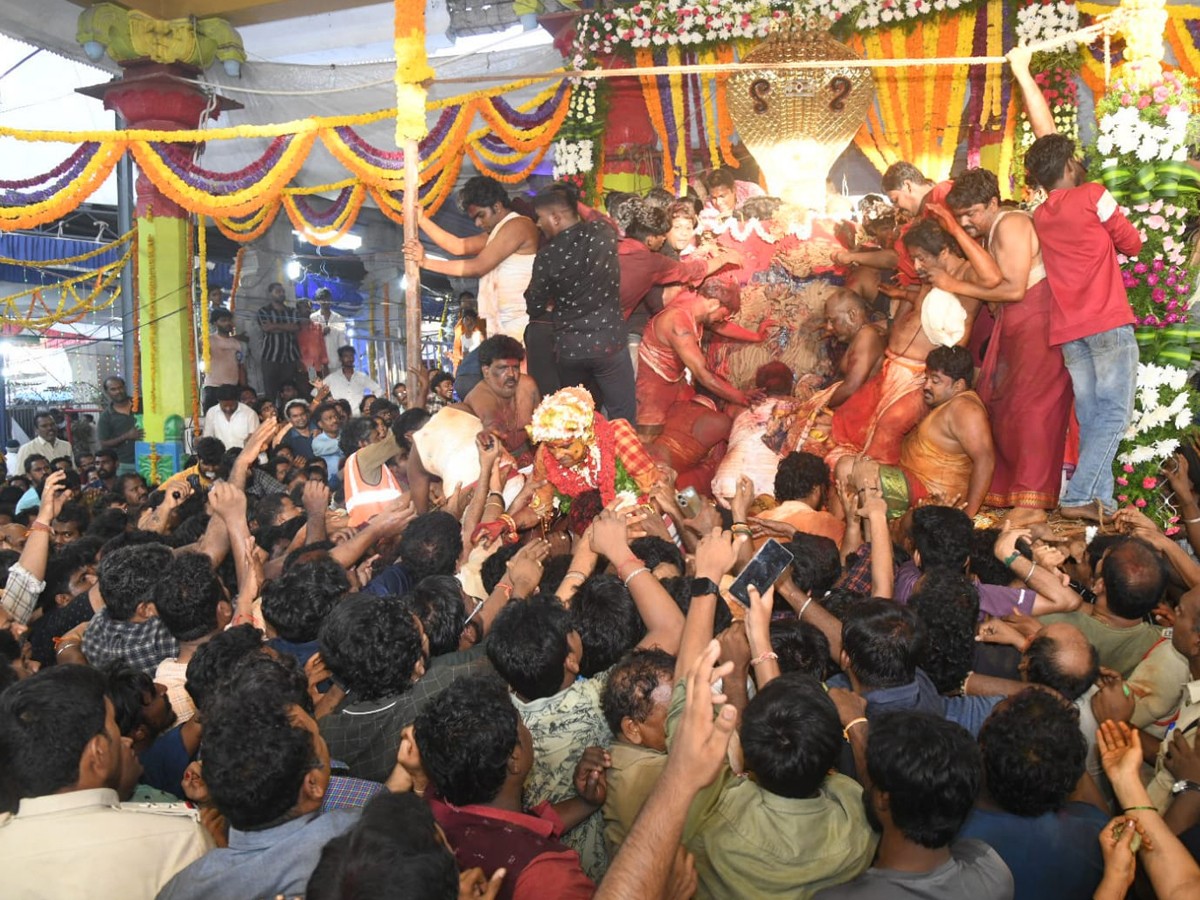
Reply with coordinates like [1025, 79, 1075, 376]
[930, 169, 1073, 526]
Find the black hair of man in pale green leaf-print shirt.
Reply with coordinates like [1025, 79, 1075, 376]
[487, 594, 575, 700]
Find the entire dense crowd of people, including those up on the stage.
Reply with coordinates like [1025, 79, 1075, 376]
[0, 50, 1200, 900]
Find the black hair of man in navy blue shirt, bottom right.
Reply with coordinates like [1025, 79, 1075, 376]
[979, 688, 1087, 818]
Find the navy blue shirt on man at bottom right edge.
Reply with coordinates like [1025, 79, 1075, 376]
[959, 803, 1109, 900]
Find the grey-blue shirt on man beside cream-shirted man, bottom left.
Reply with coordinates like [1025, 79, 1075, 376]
[158, 809, 361, 900]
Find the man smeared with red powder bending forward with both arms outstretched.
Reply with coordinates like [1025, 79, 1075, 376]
[637, 278, 770, 443]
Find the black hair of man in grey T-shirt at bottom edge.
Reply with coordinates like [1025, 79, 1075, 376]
[866, 710, 983, 850]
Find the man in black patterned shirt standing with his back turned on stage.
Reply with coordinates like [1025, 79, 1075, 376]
[526, 187, 637, 422]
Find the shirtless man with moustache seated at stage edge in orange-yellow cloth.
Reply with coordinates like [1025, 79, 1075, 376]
[850, 347, 996, 517]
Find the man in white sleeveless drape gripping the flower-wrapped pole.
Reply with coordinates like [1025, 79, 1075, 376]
[404, 175, 540, 341]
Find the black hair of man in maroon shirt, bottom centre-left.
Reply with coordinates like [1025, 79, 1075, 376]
[413, 676, 521, 806]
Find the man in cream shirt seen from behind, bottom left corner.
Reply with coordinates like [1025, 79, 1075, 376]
[0, 666, 212, 900]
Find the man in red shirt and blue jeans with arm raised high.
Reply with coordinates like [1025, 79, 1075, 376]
[1008, 48, 1141, 520]
